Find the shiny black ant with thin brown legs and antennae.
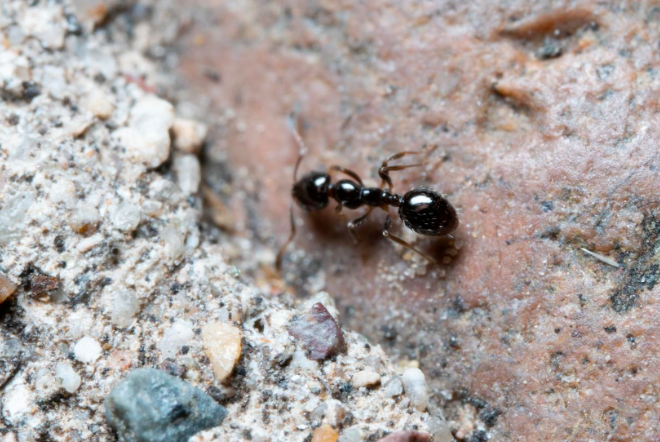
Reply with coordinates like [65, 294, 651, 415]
[275, 117, 458, 269]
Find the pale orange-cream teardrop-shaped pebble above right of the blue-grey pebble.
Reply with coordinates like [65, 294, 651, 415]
[202, 322, 242, 381]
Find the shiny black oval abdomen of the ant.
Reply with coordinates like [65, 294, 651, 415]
[399, 189, 458, 236]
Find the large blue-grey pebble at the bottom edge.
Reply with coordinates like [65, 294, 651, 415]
[105, 368, 227, 442]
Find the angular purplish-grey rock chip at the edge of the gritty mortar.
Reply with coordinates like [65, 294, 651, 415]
[287, 302, 346, 361]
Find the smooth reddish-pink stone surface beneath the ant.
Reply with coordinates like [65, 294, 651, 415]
[175, 0, 660, 441]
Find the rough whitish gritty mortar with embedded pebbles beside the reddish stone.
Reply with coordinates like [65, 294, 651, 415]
[0, 0, 452, 442]
